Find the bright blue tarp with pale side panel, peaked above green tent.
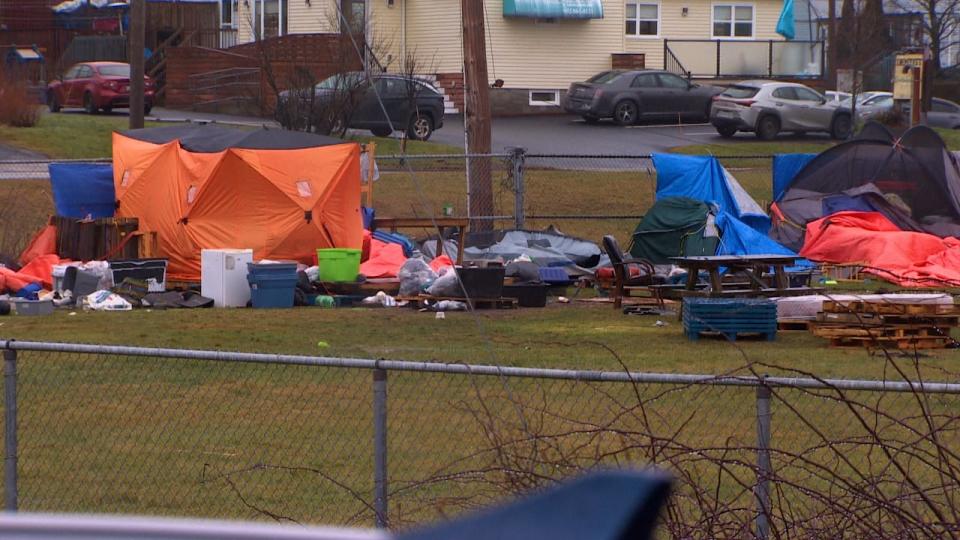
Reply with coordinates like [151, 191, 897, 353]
[653, 154, 770, 235]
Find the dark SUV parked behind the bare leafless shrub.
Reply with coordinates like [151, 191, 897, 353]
[277, 72, 443, 141]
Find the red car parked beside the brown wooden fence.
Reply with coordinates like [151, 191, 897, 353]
[47, 62, 156, 114]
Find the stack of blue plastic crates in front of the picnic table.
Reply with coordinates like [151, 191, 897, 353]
[683, 298, 777, 340]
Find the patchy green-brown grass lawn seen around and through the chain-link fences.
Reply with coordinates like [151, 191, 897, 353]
[0, 115, 956, 525]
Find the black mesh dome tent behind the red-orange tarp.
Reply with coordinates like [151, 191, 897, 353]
[770, 123, 960, 250]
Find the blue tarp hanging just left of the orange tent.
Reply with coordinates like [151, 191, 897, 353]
[49, 163, 116, 219]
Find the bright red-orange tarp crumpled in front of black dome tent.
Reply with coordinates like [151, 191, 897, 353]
[800, 212, 960, 287]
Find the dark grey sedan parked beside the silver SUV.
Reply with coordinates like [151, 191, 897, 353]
[563, 69, 721, 126]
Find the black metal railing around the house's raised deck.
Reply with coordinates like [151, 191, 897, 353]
[663, 39, 825, 79]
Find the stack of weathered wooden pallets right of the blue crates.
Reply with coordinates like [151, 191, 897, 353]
[810, 301, 960, 349]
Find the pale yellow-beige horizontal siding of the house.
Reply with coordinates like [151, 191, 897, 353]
[238, 0, 783, 90]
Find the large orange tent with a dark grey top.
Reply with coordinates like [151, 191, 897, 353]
[113, 124, 363, 281]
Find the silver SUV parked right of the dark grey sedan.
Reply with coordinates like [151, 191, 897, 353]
[710, 81, 853, 141]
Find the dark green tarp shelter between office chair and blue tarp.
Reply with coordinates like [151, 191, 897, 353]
[630, 197, 720, 264]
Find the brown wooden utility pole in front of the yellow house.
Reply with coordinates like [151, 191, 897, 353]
[460, 0, 494, 231]
